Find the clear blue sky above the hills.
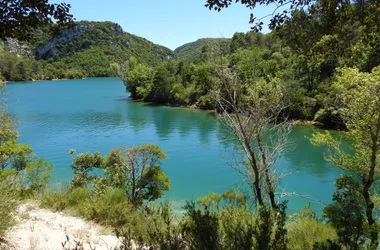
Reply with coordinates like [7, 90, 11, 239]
[60, 0, 271, 49]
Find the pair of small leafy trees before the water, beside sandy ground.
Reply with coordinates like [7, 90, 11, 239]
[69, 144, 170, 207]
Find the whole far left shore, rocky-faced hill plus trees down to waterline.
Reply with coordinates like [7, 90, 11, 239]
[0, 21, 174, 81]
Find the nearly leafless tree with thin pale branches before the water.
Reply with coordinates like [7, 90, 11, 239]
[216, 65, 292, 210]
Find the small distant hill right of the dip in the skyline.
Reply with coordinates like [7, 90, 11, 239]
[174, 38, 231, 62]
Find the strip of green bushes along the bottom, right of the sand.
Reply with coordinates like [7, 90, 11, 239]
[40, 185, 344, 250]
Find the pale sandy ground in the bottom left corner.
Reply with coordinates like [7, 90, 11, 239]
[0, 203, 120, 250]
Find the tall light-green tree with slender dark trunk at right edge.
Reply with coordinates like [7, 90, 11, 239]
[312, 67, 380, 249]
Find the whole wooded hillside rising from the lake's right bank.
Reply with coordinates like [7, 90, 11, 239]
[125, 8, 380, 127]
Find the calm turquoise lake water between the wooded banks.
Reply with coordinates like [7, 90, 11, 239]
[6, 78, 341, 215]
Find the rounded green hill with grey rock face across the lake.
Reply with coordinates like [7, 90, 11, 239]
[32, 21, 174, 76]
